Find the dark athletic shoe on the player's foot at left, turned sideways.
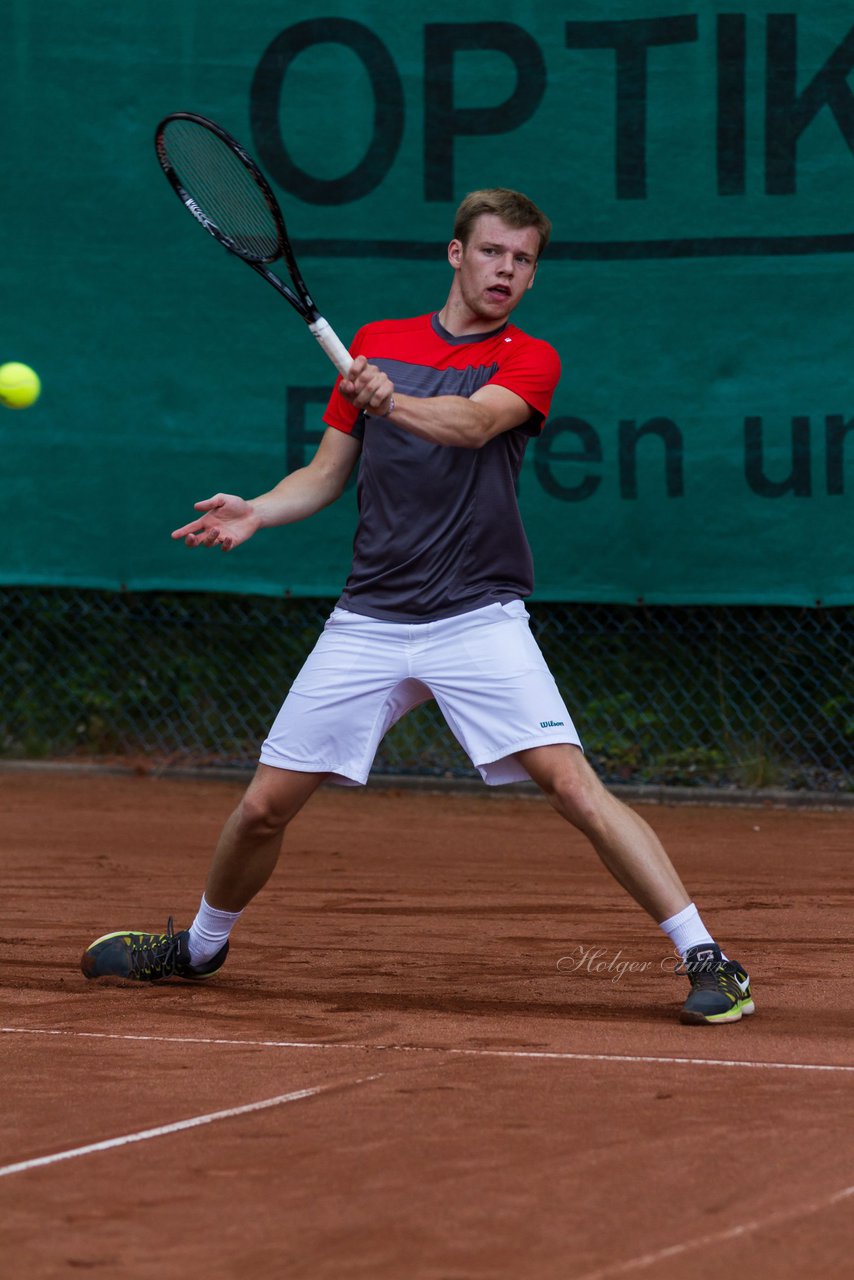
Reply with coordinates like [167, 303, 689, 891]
[81, 916, 228, 982]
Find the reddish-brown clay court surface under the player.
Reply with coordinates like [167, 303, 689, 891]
[0, 772, 854, 1280]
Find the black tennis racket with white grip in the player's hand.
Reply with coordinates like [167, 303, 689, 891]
[155, 111, 353, 378]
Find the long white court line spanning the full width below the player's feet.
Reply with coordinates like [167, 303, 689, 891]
[0, 1027, 854, 1071]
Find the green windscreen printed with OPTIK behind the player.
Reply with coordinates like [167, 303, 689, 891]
[0, 0, 854, 605]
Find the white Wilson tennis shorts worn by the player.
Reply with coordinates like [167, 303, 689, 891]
[261, 600, 581, 786]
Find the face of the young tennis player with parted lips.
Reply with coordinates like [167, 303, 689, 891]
[448, 214, 540, 328]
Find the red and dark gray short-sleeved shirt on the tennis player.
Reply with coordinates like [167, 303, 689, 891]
[324, 315, 561, 622]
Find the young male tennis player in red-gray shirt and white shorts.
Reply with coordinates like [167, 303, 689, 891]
[82, 188, 753, 1023]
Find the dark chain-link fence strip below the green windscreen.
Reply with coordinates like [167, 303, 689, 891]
[0, 588, 854, 792]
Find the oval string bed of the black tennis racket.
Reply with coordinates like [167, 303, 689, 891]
[164, 120, 280, 262]
